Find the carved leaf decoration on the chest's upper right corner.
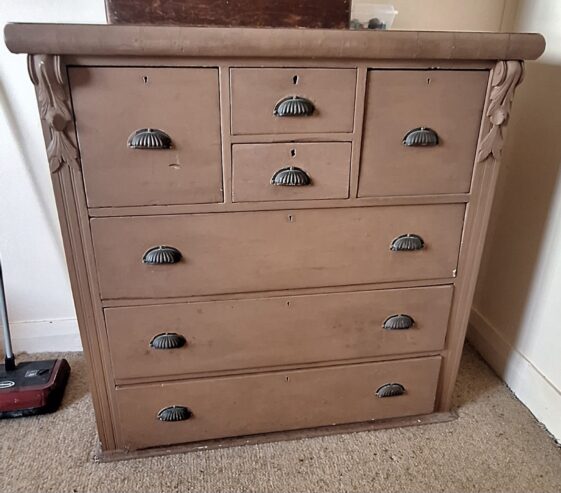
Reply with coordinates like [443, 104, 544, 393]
[476, 60, 524, 163]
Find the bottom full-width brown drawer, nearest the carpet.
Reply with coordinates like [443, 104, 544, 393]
[115, 357, 440, 449]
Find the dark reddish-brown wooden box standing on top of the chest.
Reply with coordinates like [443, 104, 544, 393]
[105, 0, 351, 29]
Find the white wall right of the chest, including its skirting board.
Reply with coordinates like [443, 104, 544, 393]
[469, 0, 561, 440]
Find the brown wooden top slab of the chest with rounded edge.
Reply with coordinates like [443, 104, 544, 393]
[4, 24, 545, 60]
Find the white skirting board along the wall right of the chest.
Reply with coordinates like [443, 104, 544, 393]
[467, 308, 561, 443]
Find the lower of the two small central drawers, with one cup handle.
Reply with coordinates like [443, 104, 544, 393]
[232, 142, 351, 202]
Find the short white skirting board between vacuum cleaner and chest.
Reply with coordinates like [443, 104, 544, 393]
[10, 318, 82, 353]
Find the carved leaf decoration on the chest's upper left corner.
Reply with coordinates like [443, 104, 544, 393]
[27, 55, 80, 173]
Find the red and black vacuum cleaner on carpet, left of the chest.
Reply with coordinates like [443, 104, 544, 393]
[0, 263, 70, 419]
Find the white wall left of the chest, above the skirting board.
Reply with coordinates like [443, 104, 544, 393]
[0, 0, 105, 351]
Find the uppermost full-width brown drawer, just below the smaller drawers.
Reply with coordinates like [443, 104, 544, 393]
[91, 204, 465, 299]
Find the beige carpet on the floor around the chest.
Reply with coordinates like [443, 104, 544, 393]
[0, 342, 561, 493]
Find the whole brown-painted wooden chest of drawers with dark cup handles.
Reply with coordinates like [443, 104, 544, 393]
[5, 24, 544, 457]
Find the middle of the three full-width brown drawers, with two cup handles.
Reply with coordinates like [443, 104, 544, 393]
[105, 286, 452, 379]
